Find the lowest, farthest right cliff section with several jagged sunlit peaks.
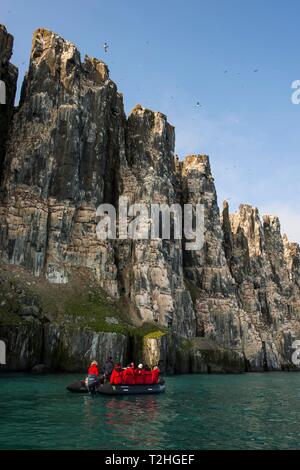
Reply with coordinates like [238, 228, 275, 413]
[219, 204, 299, 369]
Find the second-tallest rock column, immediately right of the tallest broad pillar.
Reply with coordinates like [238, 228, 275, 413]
[119, 106, 195, 337]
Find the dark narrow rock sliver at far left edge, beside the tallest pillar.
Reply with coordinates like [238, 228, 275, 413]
[0, 25, 18, 181]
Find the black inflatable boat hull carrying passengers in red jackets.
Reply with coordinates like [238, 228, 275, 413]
[67, 380, 166, 395]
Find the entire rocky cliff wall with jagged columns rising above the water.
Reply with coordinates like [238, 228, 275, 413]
[0, 27, 300, 372]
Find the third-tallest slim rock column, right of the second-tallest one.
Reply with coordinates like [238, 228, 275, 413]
[182, 155, 261, 368]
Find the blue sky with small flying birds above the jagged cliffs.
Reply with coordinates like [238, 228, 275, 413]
[0, 0, 300, 242]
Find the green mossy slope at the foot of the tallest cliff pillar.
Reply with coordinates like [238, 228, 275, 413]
[0, 265, 169, 338]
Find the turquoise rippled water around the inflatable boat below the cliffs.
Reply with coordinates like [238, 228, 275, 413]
[0, 373, 300, 450]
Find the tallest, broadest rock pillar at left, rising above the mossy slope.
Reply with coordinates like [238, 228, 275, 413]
[1, 29, 125, 296]
